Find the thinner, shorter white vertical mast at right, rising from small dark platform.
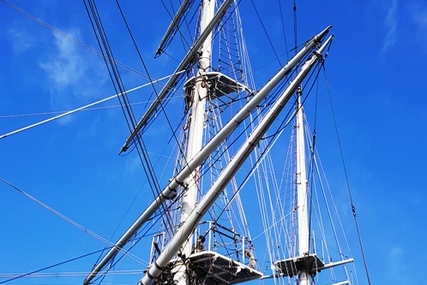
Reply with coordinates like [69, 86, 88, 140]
[296, 87, 310, 285]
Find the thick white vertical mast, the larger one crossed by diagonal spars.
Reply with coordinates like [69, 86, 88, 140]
[172, 0, 215, 285]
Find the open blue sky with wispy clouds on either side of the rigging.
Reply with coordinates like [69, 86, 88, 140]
[0, 0, 427, 284]
